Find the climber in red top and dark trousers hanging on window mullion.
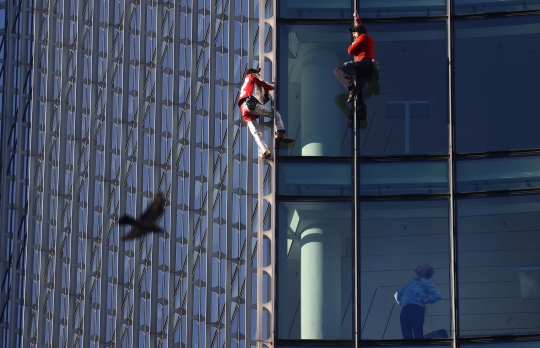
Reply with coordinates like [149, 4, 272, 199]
[334, 12, 379, 118]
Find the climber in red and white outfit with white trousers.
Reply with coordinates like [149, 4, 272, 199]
[238, 68, 294, 159]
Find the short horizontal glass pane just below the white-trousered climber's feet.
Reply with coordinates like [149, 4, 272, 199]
[278, 162, 353, 196]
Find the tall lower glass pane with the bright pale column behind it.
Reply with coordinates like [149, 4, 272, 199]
[276, 202, 354, 340]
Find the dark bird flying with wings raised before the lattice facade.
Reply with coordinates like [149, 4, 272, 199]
[118, 192, 165, 240]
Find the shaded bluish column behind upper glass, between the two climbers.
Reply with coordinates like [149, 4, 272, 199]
[300, 48, 346, 156]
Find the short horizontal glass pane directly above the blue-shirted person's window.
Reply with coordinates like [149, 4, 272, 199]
[360, 161, 448, 196]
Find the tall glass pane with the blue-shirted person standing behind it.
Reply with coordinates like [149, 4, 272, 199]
[359, 200, 451, 339]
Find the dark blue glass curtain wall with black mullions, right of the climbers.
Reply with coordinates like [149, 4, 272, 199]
[275, 0, 540, 348]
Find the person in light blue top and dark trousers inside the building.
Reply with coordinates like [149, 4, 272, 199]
[396, 263, 442, 339]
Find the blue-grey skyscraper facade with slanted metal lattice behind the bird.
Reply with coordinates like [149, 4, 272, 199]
[0, 0, 272, 347]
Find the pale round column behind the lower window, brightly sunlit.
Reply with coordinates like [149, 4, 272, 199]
[300, 225, 341, 339]
